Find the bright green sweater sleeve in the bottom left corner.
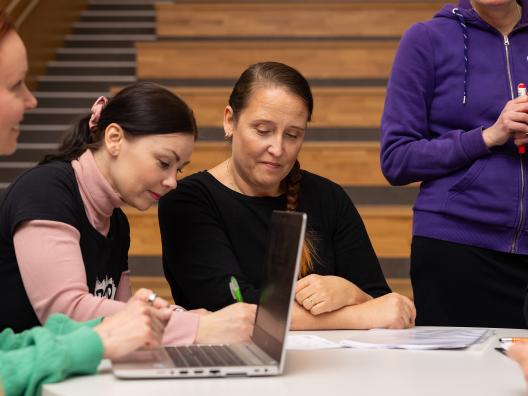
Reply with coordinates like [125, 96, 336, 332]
[0, 315, 103, 396]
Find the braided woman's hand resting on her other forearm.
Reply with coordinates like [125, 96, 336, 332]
[295, 274, 372, 315]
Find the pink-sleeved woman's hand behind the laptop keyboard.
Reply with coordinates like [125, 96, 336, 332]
[195, 303, 257, 344]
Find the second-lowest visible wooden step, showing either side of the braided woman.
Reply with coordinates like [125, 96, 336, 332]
[124, 205, 412, 258]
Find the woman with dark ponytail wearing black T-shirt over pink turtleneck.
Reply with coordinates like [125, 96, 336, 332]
[0, 82, 255, 344]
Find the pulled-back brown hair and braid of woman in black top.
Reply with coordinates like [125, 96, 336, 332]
[229, 62, 315, 276]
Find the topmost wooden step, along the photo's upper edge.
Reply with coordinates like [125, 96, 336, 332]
[156, 2, 440, 38]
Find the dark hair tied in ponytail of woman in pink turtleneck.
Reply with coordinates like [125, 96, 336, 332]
[42, 82, 198, 163]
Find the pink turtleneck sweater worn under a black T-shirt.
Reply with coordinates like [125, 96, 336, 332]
[13, 150, 199, 345]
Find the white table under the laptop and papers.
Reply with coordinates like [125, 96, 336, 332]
[42, 329, 528, 396]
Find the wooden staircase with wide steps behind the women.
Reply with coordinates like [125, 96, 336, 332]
[0, 0, 454, 297]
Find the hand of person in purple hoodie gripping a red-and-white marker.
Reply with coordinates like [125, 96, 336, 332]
[482, 96, 528, 148]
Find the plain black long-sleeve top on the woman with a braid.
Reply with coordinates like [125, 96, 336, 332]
[158, 171, 390, 311]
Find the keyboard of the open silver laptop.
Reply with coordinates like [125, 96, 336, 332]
[165, 345, 246, 367]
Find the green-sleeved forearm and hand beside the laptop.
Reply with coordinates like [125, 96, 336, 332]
[0, 289, 172, 396]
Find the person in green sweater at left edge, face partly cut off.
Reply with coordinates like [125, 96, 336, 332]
[0, 9, 172, 396]
